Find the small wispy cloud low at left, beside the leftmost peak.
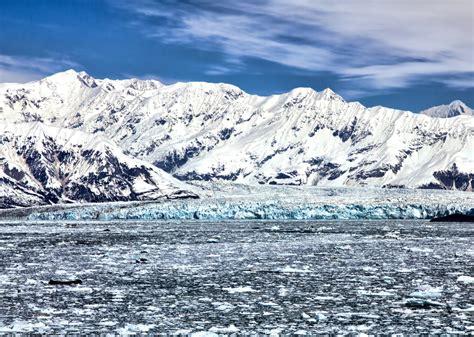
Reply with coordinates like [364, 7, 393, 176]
[0, 54, 78, 83]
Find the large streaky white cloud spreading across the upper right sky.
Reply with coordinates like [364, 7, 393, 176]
[112, 0, 474, 89]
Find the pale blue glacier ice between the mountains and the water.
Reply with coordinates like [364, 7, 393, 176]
[0, 182, 474, 221]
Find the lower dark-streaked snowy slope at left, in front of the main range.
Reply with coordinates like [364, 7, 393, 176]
[0, 122, 195, 208]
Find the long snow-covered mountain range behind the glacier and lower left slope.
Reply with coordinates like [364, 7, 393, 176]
[0, 71, 474, 190]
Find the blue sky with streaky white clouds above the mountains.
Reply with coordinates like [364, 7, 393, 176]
[0, 0, 474, 111]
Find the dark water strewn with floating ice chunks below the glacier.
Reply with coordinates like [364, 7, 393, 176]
[0, 221, 474, 334]
